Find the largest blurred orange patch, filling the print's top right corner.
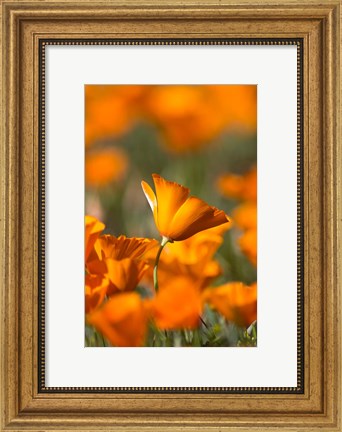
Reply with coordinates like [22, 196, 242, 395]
[145, 85, 256, 152]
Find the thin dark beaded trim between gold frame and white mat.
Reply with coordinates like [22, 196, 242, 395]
[38, 38, 304, 394]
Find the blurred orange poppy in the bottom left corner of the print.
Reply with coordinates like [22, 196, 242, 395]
[87, 293, 147, 347]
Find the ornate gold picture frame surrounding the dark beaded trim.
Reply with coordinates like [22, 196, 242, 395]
[0, 0, 342, 431]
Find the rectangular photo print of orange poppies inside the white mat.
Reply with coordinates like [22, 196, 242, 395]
[85, 85, 257, 347]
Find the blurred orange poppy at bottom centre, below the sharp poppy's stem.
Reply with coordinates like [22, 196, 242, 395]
[146, 277, 202, 330]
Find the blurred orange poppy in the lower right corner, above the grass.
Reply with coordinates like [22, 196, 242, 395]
[203, 282, 257, 327]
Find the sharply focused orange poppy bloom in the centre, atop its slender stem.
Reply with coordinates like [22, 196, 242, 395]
[141, 174, 229, 242]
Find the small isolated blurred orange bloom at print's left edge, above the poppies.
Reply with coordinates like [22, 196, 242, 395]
[85, 147, 128, 187]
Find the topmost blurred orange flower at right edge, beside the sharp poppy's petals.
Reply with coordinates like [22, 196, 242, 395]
[217, 167, 257, 201]
